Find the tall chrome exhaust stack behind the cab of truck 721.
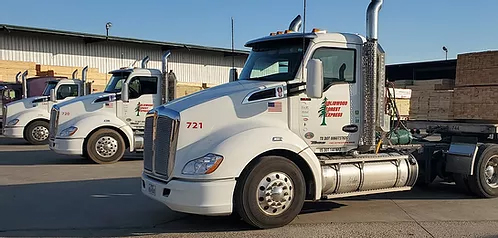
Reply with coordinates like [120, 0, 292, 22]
[359, 0, 383, 152]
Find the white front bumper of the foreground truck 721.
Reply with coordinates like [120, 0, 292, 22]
[141, 174, 236, 216]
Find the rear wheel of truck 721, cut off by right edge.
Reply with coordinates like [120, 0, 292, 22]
[468, 144, 498, 198]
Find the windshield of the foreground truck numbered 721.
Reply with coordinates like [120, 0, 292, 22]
[240, 38, 307, 81]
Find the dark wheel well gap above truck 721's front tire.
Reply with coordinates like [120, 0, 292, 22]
[242, 149, 316, 200]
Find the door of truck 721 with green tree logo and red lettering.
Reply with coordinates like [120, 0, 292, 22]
[300, 47, 361, 153]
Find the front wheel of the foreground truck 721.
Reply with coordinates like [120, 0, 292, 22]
[234, 156, 306, 229]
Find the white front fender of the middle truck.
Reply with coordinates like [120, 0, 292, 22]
[57, 113, 135, 152]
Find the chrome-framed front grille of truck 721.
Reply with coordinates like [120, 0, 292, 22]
[144, 109, 180, 179]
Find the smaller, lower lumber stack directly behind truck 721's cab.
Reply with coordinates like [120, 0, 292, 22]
[395, 79, 455, 121]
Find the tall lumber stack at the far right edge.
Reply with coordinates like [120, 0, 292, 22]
[454, 51, 498, 121]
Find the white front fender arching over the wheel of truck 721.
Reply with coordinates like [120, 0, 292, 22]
[181, 127, 322, 199]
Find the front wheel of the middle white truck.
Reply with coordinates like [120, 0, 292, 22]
[83, 129, 126, 164]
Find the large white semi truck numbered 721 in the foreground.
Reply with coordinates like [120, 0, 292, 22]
[141, 0, 498, 228]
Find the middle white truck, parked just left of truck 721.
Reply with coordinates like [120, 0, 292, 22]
[49, 51, 174, 164]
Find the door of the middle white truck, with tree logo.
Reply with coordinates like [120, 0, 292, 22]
[117, 76, 159, 129]
